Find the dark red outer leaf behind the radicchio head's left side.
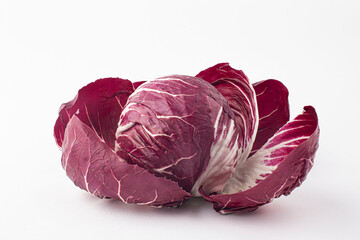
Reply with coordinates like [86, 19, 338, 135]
[54, 78, 134, 149]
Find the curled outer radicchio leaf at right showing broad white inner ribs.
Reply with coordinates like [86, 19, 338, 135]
[202, 106, 319, 213]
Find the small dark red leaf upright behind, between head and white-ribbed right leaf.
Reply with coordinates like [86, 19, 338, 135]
[250, 79, 289, 156]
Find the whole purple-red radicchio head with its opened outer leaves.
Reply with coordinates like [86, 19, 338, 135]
[54, 63, 319, 214]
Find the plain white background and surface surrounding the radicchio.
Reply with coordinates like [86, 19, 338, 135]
[0, 0, 360, 239]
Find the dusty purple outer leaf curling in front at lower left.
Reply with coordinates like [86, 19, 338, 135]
[62, 114, 191, 207]
